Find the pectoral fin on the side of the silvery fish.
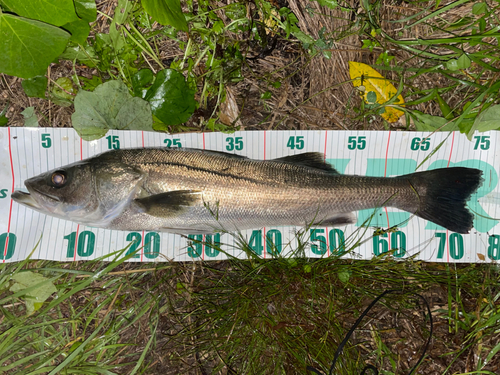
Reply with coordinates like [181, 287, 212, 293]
[134, 190, 201, 218]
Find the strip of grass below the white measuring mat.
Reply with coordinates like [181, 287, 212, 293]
[0, 239, 500, 374]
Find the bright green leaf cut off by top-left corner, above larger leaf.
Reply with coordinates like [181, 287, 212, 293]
[0, 0, 78, 26]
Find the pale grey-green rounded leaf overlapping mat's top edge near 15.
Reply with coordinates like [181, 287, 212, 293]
[71, 81, 153, 141]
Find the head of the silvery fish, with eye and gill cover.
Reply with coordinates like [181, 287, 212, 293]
[11, 158, 142, 227]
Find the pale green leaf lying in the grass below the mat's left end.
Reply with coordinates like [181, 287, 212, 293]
[9, 271, 57, 315]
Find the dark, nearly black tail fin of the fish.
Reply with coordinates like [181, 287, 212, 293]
[404, 167, 483, 234]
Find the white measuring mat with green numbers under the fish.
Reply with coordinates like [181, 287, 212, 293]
[0, 128, 500, 262]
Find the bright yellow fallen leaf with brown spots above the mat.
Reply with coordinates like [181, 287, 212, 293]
[349, 61, 405, 122]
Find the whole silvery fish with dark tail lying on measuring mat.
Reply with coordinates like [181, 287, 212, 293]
[11, 148, 483, 234]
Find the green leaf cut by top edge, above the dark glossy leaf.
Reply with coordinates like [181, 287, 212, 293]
[142, 0, 189, 32]
